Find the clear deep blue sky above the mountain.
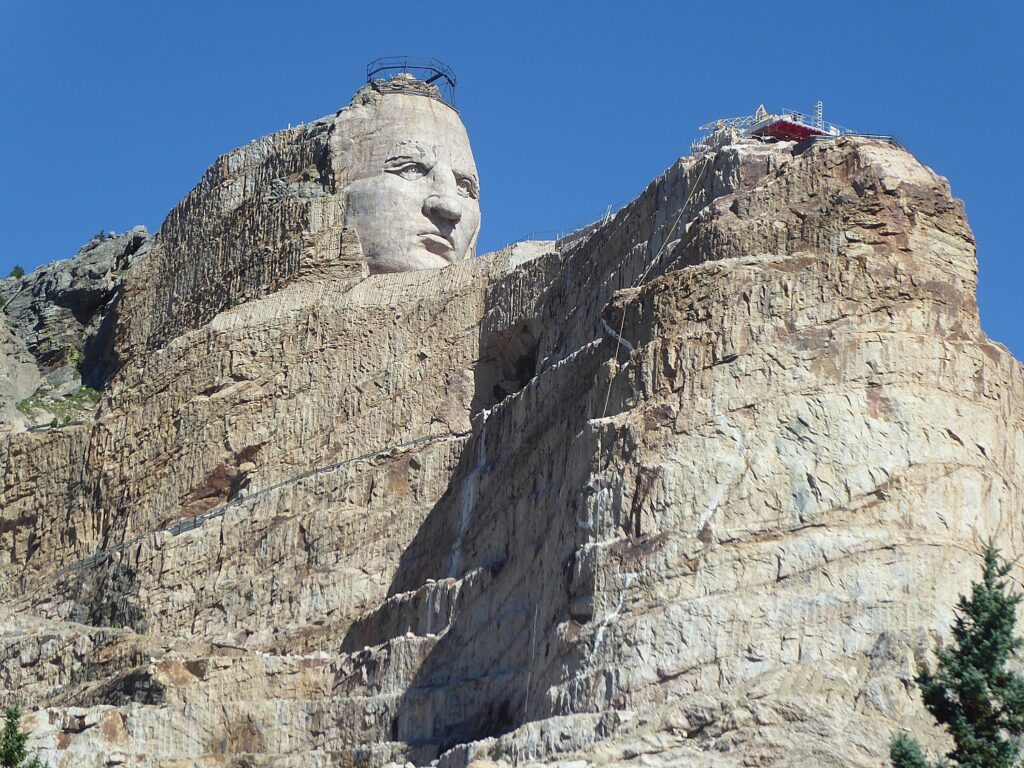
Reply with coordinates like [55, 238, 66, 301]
[0, 0, 1024, 358]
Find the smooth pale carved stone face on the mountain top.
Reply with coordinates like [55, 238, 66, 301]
[335, 93, 480, 272]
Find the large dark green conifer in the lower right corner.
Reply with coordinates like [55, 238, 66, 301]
[889, 544, 1024, 768]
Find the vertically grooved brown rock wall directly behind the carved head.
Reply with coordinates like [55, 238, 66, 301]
[119, 118, 358, 360]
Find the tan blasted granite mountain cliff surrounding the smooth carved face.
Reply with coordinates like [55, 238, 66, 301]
[0, 103, 1024, 768]
